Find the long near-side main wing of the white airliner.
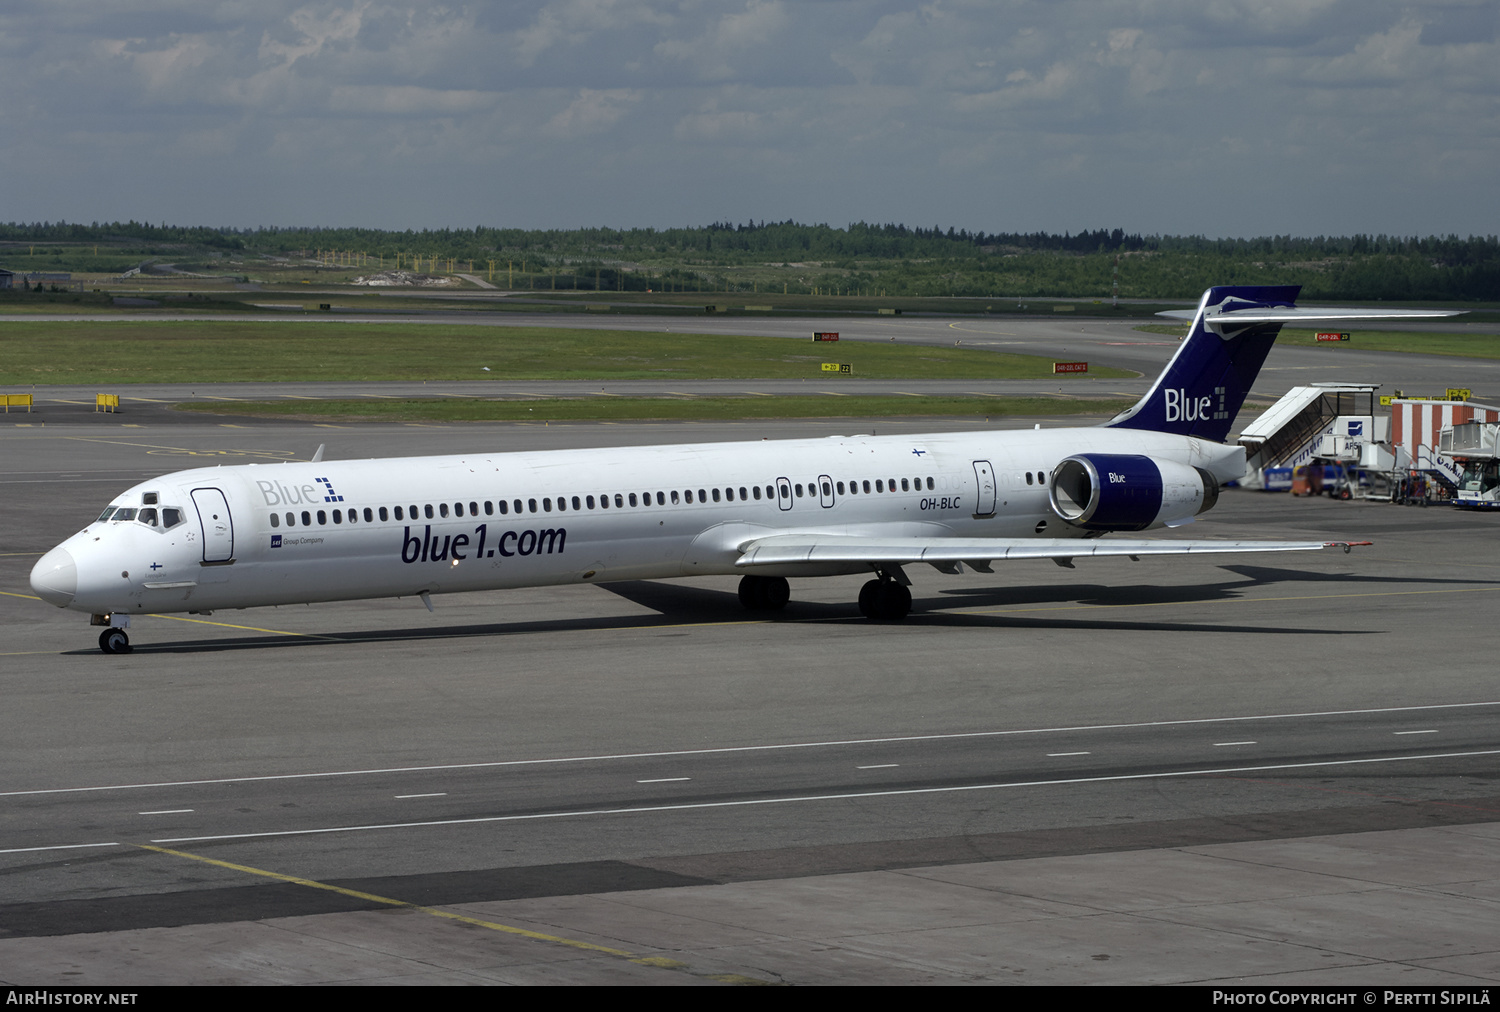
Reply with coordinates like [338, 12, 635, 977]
[735, 534, 1370, 568]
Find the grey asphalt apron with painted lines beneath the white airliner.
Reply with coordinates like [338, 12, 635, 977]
[0, 407, 1500, 985]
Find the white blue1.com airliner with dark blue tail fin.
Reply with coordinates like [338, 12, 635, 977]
[32, 286, 1454, 654]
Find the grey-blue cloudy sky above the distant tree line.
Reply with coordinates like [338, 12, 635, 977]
[0, 0, 1500, 235]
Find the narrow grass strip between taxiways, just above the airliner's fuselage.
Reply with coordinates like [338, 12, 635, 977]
[179, 396, 1133, 421]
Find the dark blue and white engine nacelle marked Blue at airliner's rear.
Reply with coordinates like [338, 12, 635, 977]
[1047, 453, 1218, 531]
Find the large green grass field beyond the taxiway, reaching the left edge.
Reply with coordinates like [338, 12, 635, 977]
[0, 321, 1134, 385]
